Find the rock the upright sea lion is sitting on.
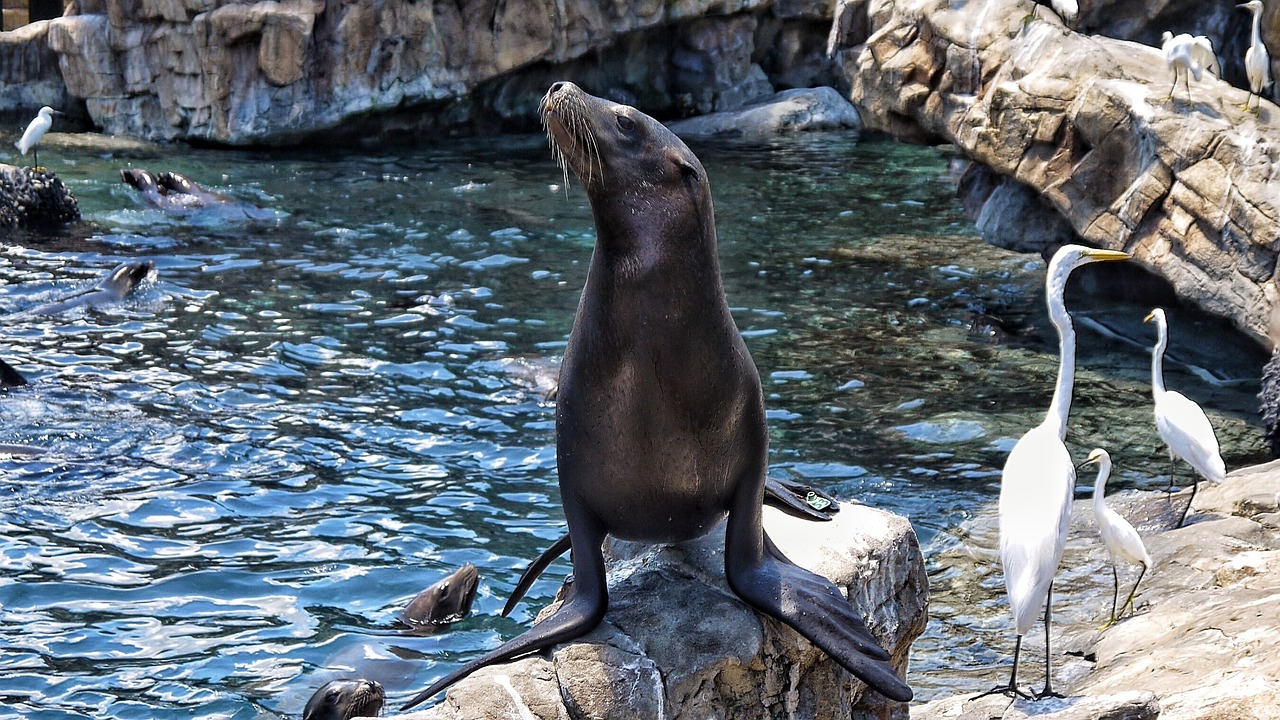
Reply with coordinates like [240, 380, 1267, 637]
[392, 503, 928, 720]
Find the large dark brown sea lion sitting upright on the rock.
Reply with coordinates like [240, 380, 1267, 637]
[404, 82, 911, 708]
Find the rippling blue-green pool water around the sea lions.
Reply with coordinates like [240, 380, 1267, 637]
[0, 135, 1263, 719]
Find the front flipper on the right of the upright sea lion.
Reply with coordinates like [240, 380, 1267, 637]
[724, 482, 913, 702]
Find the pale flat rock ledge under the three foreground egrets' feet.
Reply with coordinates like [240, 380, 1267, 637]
[911, 461, 1280, 720]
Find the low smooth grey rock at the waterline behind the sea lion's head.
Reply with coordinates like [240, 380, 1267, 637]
[668, 87, 861, 140]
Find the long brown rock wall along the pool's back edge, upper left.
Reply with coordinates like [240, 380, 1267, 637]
[0, 0, 836, 145]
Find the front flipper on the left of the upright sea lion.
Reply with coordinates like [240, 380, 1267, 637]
[401, 497, 609, 711]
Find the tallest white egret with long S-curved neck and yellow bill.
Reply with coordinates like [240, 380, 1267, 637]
[991, 245, 1129, 698]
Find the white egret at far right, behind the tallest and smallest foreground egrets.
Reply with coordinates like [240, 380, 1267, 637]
[1143, 307, 1226, 528]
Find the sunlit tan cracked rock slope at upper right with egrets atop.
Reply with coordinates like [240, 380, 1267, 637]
[837, 0, 1280, 345]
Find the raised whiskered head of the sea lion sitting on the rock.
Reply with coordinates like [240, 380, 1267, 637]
[541, 82, 709, 201]
